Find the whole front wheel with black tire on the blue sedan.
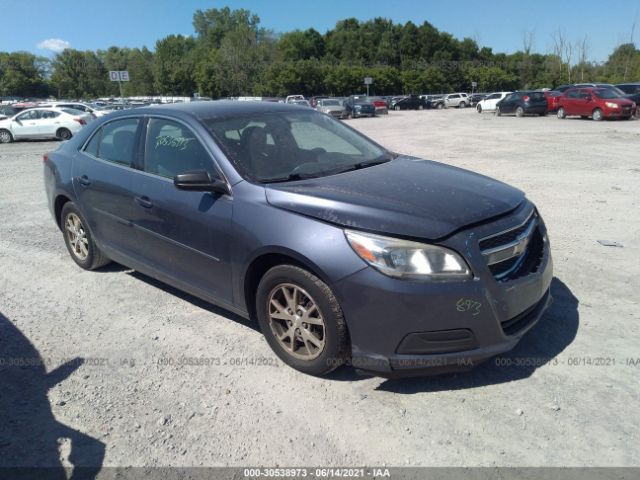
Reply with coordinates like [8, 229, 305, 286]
[256, 265, 349, 376]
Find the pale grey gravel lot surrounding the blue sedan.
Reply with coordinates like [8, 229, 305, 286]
[0, 109, 640, 466]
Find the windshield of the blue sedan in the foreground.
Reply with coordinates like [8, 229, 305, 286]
[203, 110, 391, 183]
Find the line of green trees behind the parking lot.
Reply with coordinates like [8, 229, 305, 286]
[0, 7, 640, 99]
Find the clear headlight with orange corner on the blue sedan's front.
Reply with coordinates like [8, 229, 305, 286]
[345, 230, 471, 279]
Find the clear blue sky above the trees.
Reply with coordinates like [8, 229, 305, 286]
[0, 0, 640, 61]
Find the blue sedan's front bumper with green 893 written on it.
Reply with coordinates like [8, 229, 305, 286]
[335, 204, 553, 377]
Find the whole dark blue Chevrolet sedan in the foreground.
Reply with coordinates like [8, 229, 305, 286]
[44, 102, 552, 376]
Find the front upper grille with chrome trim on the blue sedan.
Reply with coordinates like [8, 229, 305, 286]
[479, 213, 545, 282]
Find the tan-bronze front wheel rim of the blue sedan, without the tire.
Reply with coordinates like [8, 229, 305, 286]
[267, 283, 326, 360]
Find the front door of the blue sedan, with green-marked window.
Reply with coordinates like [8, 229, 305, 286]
[127, 117, 233, 303]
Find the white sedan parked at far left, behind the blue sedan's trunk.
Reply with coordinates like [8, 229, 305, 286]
[0, 107, 92, 143]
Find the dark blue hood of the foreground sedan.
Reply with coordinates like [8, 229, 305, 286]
[266, 157, 525, 240]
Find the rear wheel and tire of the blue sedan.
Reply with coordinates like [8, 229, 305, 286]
[60, 202, 110, 270]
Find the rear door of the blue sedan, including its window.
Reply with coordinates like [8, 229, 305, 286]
[72, 117, 142, 258]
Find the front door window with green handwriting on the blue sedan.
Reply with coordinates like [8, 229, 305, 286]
[144, 118, 218, 178]
